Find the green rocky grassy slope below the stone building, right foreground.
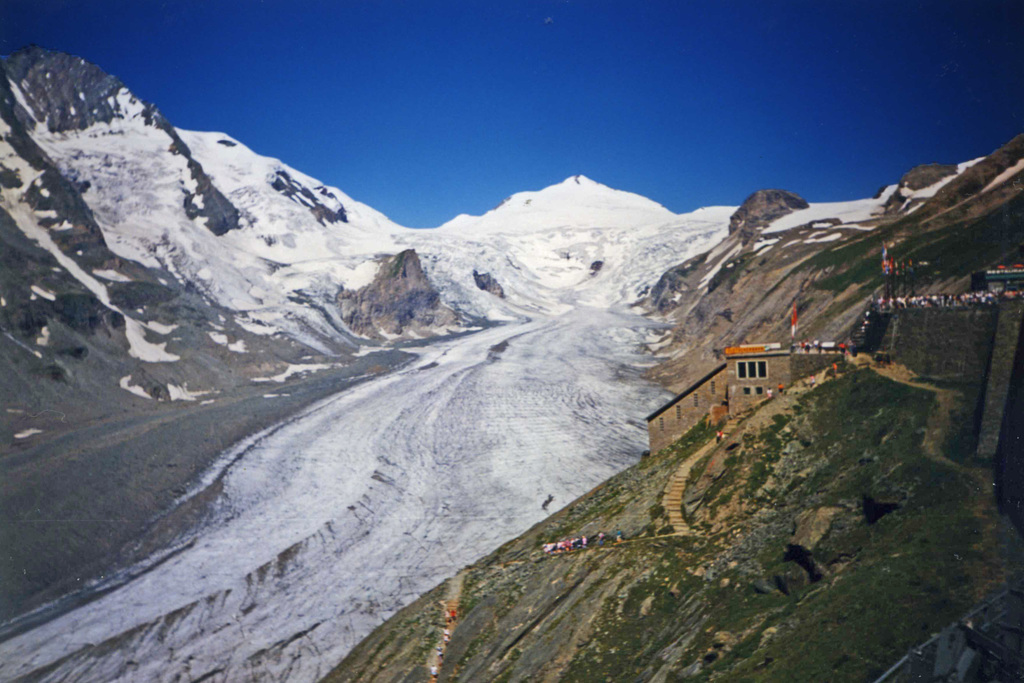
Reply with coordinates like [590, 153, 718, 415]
[328, 370, 1004, 681]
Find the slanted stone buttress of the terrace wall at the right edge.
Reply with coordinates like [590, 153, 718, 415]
[978, 301, 1024, 460]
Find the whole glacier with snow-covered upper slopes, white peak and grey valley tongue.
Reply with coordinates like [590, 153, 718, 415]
[0, 93, 734, 682]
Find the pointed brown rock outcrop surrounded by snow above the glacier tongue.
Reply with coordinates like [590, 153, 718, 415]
[338, 249, 459, 338]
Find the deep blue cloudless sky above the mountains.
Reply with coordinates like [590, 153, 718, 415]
[0, 0, 1024, 227]
